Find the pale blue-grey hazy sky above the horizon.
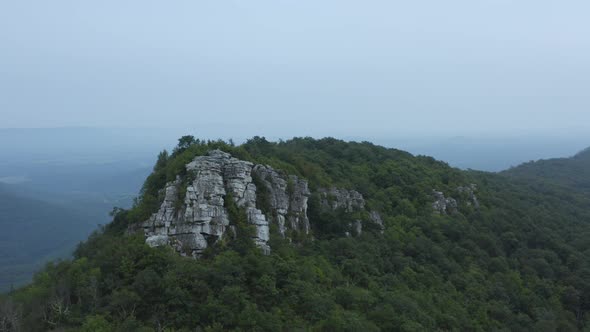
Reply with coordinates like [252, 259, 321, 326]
[0, 0, 590, 137]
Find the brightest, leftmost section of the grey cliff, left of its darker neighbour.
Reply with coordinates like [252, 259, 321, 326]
[142, 150, 270, 256]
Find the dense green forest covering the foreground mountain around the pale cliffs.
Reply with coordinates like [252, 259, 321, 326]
[0, 136, 590, 331]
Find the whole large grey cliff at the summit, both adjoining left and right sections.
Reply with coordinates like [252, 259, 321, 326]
[142, 150, 310, 257]
